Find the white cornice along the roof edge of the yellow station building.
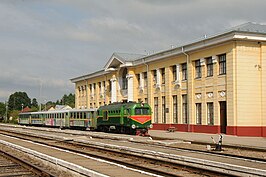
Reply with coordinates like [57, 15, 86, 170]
[70, 24, 266, 83]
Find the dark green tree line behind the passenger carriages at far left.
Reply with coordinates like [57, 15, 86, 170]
[0, 92, 75, 120]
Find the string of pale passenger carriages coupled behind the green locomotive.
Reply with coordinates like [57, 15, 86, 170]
[19, 109, 96, 129]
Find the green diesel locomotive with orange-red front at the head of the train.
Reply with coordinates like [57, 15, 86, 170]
[97, 102, 152, 135]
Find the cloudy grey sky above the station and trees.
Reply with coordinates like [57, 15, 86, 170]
[0, 0, 266, 103]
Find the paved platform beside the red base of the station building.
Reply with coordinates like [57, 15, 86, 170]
[149, 130, 266, 150]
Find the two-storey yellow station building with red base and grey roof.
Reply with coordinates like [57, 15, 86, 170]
[71, 23, 266, 137]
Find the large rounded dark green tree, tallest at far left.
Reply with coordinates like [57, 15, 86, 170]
[8, 92, 31, 111]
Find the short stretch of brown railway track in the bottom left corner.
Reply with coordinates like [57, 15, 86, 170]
[0, 148, 54, 177]
